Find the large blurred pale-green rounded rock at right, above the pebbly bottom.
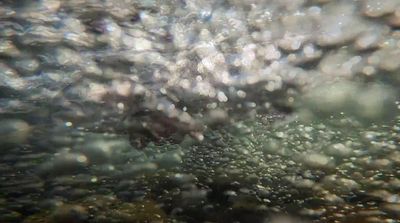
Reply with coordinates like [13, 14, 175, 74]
[303, 82, 398, 124]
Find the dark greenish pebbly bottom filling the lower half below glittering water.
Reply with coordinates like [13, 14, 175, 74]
[0, 116, 400, 223]
